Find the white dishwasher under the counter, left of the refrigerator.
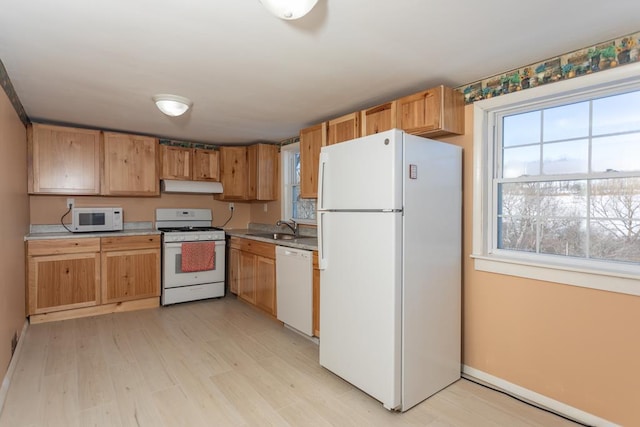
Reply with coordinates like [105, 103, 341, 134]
[276, 246, 313, 336]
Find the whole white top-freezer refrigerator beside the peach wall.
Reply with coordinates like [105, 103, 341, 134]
[318, 129, 462, 411]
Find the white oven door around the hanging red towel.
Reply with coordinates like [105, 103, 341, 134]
[162, 240, 225, 289]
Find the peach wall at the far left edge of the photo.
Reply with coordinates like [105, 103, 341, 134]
[0, 89, 29, 377]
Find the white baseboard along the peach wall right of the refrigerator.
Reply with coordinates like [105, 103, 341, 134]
[462, 365, 620, 427]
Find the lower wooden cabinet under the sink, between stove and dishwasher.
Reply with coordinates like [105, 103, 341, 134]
[229, 237, 277, 317]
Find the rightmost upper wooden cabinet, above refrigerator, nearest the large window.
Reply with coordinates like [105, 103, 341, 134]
[396, 86, 464, 137]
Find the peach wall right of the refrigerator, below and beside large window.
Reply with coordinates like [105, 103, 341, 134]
[443, 104, 640, 426]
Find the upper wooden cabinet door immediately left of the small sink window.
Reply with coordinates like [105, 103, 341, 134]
[247, 144, 279, 201]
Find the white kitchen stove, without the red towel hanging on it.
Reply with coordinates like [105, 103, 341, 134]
[156, 209, 225, 305]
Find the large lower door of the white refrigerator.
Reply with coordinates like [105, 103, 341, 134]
[319, 212, 402, 409]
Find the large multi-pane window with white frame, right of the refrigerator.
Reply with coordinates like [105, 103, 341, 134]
[473, 64, 640, 295]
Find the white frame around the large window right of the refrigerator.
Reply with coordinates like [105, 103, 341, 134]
[471, 63, 640, 296]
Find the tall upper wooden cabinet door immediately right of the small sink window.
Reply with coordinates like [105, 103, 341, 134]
[300, 123, 327, 199]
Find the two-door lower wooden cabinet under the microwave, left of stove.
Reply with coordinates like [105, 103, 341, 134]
[26, 235, 160, 323]
